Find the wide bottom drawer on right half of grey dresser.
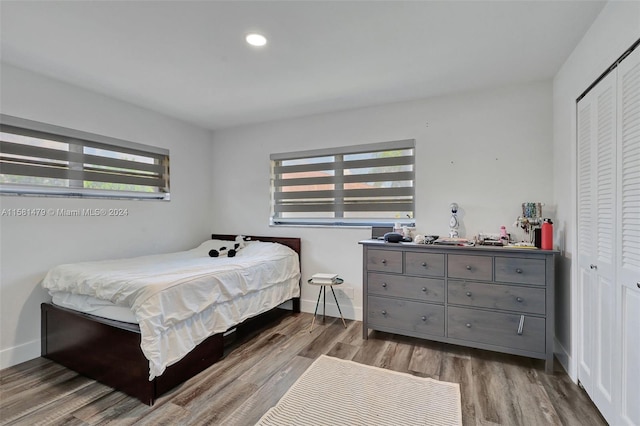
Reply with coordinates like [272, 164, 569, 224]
[447, 306, 546, 353]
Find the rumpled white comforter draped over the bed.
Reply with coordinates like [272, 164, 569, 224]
[42, 240, 300, 380]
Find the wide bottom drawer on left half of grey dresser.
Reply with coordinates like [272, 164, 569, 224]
[367, 296, 444, 336]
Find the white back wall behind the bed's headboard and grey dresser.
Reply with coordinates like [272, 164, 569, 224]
[211, 81, 555, 319]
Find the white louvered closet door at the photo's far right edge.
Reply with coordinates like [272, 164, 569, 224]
[617, 48, 640, 425]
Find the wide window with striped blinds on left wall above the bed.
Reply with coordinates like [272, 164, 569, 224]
[0, 115, 169, 200]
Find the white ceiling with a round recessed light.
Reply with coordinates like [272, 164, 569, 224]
[0, 0, 606, 129]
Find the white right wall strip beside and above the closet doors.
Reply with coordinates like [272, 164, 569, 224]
[553, 1, 640, 380]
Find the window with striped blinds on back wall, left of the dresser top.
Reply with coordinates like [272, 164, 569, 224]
[271, 139, 415, 225]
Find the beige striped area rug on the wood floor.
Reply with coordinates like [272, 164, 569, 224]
[257, 355, 462, 426]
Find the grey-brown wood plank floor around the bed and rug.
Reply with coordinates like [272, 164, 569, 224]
[0, 313, 606, 426]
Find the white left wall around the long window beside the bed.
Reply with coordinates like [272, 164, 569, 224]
[0, 64, 212, 368]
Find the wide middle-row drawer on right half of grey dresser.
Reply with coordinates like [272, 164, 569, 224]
[447, 280, 546, 315]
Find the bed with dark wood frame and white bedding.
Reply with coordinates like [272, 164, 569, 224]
[41, 234, 300, 405]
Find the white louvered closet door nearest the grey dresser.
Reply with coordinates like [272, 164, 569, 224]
[578, 66, 620, 419]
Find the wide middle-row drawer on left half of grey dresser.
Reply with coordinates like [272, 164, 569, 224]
[367, 273, 444, 303]
